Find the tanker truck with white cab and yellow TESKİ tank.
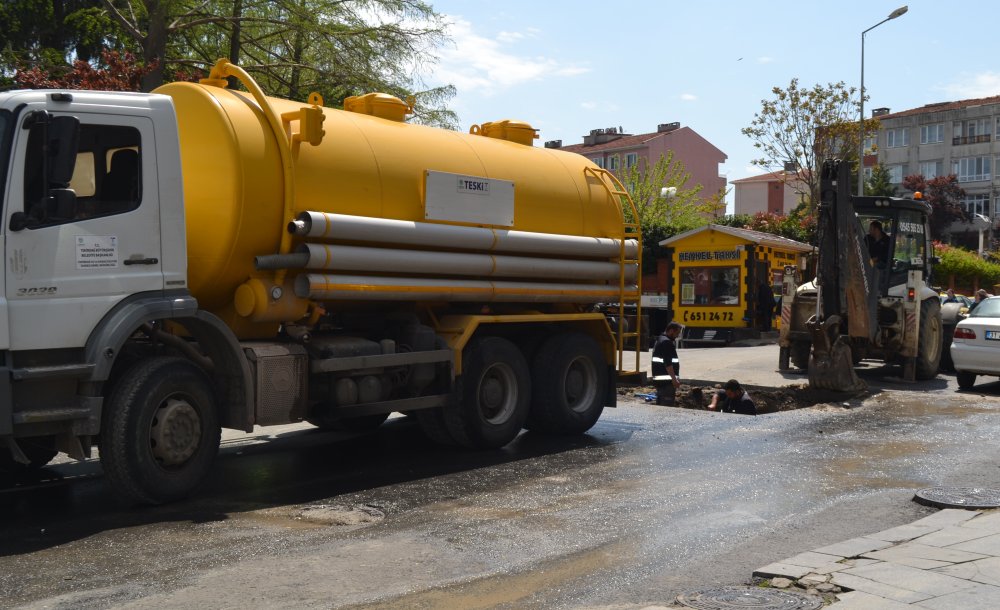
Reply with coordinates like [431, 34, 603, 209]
[0, 61, 641, 503]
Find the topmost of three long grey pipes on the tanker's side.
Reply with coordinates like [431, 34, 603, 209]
[288, 212, 638, 259]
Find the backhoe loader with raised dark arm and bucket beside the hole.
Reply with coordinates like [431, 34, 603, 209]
[779, 161, 943, 392]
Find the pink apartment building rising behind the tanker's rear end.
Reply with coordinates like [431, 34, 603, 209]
[545, 123, 727, 199]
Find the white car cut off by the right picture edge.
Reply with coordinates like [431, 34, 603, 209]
[951, 297, 1000, 389]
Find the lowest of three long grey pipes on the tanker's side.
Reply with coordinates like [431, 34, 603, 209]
[295, 273, 638, 303]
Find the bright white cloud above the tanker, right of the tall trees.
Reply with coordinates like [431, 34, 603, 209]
[432, 17, 590, 95]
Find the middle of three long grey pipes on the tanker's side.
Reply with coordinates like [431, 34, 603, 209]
[292, 244, 637, 282]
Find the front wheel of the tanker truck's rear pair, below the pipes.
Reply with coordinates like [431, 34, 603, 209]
[444, 337, 531, 449]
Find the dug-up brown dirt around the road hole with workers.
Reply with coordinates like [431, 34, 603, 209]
[619, 384, 868, 414]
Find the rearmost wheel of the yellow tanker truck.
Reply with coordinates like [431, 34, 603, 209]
[528, 332, 608, 434]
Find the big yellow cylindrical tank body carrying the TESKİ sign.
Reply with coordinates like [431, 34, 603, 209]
[157, 66, 623, 330]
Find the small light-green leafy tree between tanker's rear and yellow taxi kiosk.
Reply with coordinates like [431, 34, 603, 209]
[619, 151, 725, 273]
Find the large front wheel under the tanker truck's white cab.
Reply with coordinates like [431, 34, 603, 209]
[100, 357, 221, 504]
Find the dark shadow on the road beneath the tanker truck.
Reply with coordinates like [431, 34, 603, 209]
[0, 418, 635, 557]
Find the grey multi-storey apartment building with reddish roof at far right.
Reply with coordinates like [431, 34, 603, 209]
[865, 95, 1000, 226]
